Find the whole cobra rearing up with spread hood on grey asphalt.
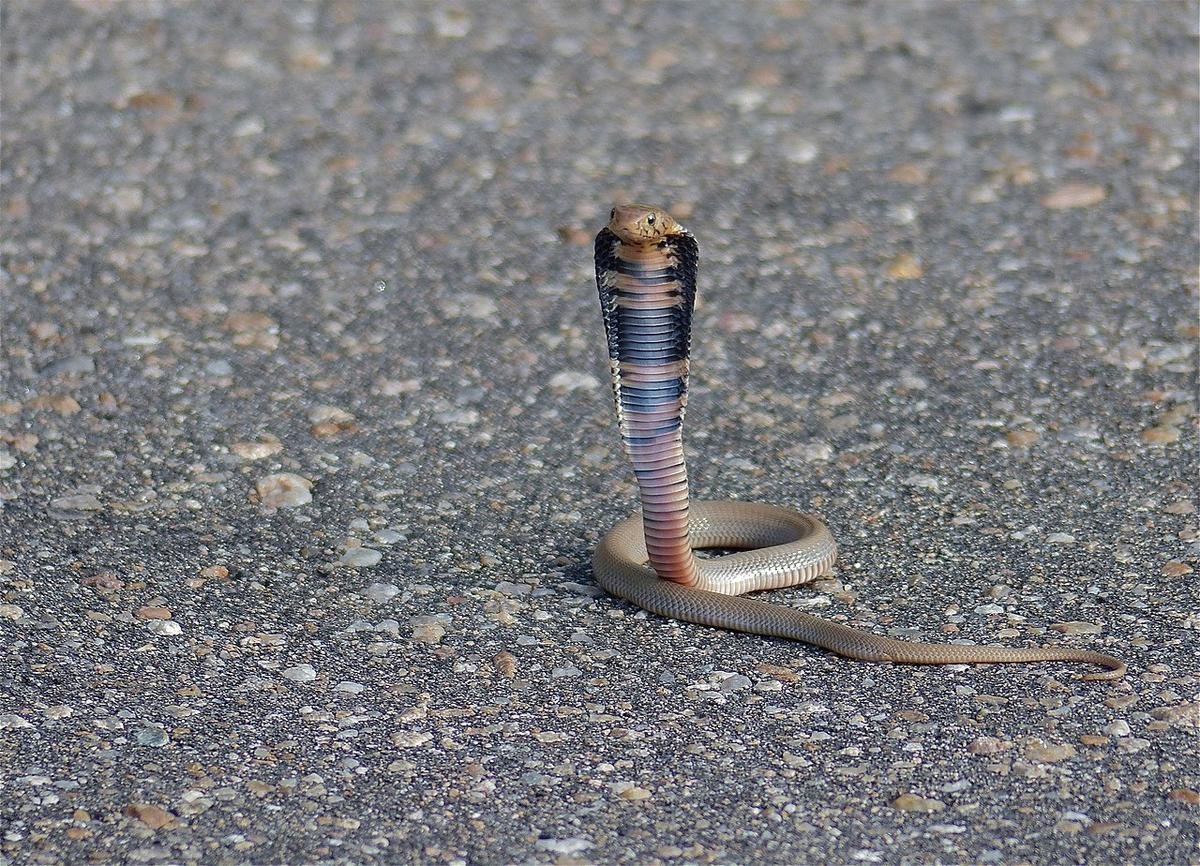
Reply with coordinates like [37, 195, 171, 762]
[592, 204, 1126, 680]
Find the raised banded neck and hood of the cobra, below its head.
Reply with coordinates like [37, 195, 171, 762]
[598, 232, 697, 585]
